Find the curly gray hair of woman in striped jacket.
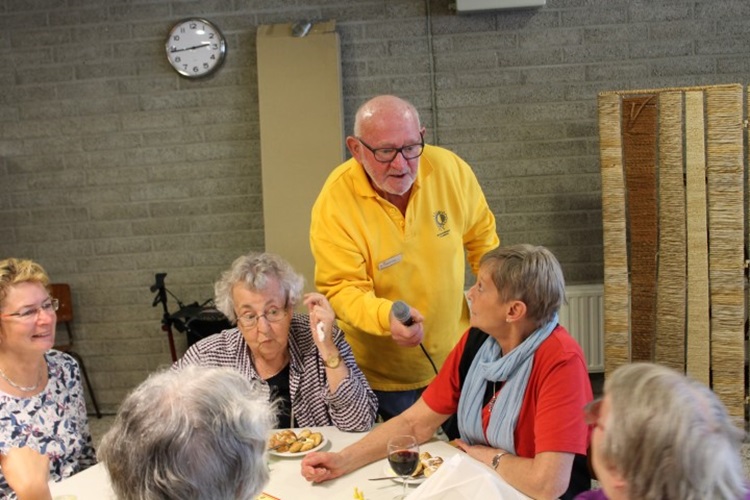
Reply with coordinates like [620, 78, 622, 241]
[214, 252, 305, 323]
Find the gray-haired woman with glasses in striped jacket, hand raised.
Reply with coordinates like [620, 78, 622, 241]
[173, 253, 377, 431]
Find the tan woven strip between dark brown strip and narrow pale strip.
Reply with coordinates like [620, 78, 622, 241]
[654, 91, 687, 372]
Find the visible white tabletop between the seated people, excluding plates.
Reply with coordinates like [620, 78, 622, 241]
[50, 427, 528, 500]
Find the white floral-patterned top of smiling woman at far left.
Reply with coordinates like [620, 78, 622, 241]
[0, 350, 96, 498]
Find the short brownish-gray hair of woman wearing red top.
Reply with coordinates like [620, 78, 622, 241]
[480, 244, 565, 325]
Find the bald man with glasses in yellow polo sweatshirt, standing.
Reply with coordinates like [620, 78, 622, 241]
[310, 95, 499, 419]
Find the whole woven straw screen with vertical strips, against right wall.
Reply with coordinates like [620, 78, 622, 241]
[599, 85, 750, 419]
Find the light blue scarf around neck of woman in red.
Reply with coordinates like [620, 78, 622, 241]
[458, 314, 557, 454]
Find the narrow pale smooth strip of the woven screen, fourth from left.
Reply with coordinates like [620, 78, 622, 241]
[685, 91, 711, 385]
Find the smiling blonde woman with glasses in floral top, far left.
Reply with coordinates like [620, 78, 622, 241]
[0, 258, 96, 497]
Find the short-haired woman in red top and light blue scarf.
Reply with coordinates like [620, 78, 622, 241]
[302, 245, 592, 498]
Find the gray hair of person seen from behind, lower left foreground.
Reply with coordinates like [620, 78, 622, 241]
[98, 366, 275, 500]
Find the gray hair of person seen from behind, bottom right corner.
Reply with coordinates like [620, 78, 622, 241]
[597, 363, 745, 500]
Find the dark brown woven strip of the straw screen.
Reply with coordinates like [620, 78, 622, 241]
[622, 95, 659, 361]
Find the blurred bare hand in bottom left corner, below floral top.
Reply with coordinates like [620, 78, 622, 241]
[0, 446, 52, 500]
